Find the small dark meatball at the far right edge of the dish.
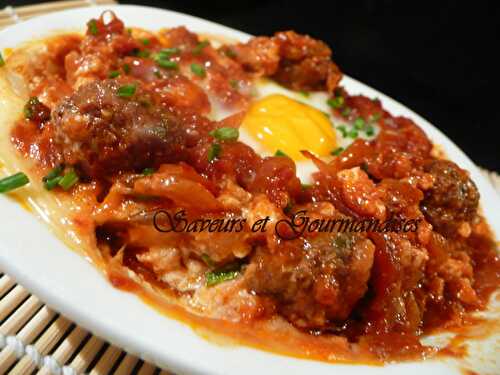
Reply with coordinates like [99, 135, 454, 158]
[420, 160, 479, 236]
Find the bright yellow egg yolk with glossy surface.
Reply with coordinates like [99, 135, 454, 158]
[242, 94, 336, 160]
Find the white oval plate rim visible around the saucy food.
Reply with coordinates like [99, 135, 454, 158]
[0, 6, 500, 375]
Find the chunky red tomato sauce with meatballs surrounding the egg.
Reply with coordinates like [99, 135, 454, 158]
[4, 11, 500, 364]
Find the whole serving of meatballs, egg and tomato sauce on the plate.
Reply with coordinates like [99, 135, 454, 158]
[0, 12, 500, 363]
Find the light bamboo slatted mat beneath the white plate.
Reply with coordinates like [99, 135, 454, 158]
[0, 0, 500, 375]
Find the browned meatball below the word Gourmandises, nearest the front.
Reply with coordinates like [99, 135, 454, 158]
[245, 233, 375, 329]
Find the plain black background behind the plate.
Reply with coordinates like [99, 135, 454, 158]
[0, 0, 500, 171]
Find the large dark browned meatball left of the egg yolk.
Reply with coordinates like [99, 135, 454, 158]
[52, 80, 195, 178]
